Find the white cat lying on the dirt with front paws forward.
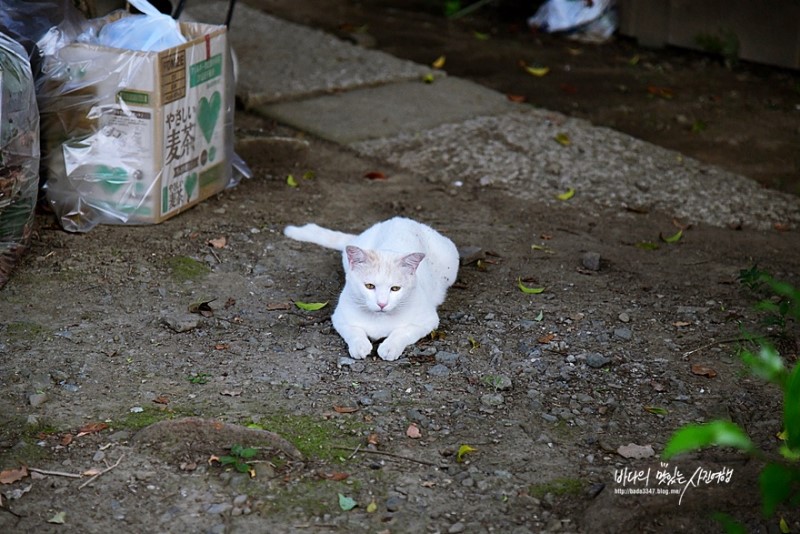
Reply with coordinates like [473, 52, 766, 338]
[284, 217, 458, 361]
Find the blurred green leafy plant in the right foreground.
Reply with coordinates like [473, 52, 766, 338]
[662, 267, 800, 533]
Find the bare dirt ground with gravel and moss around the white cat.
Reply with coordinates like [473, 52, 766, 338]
[0, 2, 800, 534]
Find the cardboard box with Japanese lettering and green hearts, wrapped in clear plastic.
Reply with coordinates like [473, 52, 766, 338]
[40, 17, 234, 231]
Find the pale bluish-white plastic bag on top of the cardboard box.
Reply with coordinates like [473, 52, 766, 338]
[96, 0, 186, 52]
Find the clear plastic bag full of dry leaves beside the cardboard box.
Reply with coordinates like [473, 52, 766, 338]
[0, 33, 39, 287]
